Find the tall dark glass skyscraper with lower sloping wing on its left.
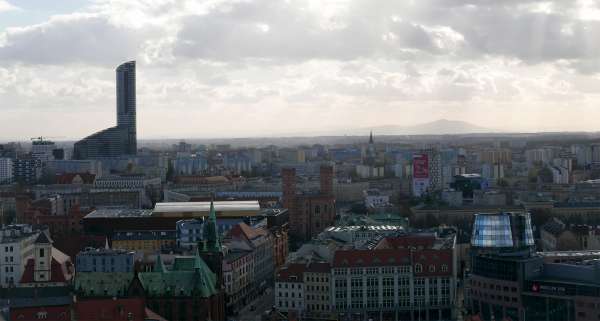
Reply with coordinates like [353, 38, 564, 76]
[73, 61, 137, 159]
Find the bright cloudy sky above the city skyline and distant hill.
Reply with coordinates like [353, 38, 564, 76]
[0, 0, 600, 139]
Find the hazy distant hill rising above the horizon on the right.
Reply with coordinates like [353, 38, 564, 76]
[372, 119, 495, 135]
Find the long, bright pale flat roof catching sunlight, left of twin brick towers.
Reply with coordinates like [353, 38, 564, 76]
[154, 200, 260, 213]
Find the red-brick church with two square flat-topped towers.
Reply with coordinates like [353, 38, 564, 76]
[281, 165, 335, 241]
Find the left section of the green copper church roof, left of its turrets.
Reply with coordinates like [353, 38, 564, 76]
[75, 272, 133, 297]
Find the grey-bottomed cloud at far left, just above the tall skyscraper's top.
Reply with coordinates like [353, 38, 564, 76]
[0, 13, 161, 65]
